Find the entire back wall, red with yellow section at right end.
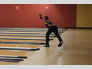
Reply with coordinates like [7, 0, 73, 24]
[0, 4, 92, 28]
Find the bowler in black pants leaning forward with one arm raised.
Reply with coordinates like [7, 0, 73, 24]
[39, 14, 63, 47]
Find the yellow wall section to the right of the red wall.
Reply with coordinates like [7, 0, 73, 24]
[76, 4, 92, 28]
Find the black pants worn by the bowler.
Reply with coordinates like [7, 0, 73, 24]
[46, 26, 62, 45]
